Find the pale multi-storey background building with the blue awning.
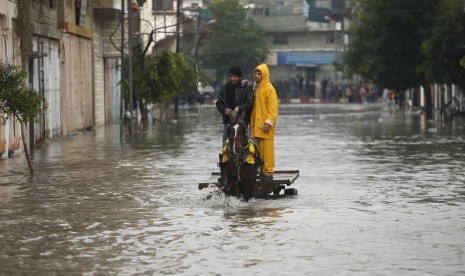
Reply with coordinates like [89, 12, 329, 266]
[244, 0, 347, 97]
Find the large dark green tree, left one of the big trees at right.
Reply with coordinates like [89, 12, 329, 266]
[344, 0, 440, 117]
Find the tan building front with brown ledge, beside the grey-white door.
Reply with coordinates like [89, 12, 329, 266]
[58, 0, 95, 135]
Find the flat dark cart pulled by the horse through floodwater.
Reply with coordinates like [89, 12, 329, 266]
[199, 170, 299, 197]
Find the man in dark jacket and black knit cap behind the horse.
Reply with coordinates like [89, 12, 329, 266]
[216, 66, 254, 143]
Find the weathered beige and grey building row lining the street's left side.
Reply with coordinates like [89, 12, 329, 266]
[0, 0, 127, 158]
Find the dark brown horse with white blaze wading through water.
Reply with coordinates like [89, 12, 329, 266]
[220, 112, 261, 201]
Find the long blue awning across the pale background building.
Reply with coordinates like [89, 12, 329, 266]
[278, 51, 336, 67]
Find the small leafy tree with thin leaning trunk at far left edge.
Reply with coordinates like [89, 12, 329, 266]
[0, 62, 42, 177]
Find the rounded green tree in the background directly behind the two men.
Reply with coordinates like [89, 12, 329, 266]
[199, 0, 269, 79]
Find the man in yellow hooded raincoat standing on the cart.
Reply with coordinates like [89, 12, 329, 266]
[250, 64, 278, 180]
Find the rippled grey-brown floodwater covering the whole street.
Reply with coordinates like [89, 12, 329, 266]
[0, 104, 465, 275]
